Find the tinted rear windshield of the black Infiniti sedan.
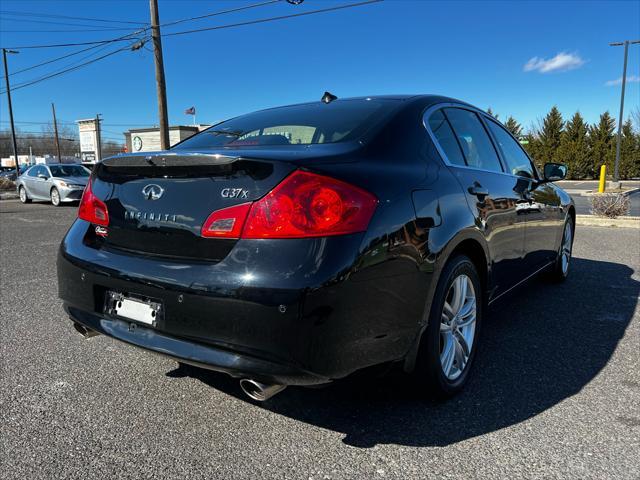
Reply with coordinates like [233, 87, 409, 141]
[174, 99, 399, 150]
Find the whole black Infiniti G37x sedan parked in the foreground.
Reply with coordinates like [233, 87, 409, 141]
[58, 95, 575, 400]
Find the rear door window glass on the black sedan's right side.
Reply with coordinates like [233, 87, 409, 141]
[444, 108, 502, 172]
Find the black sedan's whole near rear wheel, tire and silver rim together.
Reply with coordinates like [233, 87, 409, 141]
[414, 255, 484, 399]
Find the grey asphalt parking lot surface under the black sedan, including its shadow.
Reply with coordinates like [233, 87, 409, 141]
[0, 201, 640, 479]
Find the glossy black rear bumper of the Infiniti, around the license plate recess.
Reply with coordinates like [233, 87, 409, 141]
[58, 220, 430, 385]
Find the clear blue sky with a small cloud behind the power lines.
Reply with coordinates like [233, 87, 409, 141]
[0, 0, 640, 139]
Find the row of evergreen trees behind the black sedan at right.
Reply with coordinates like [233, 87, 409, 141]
[487, 106, 640, 179]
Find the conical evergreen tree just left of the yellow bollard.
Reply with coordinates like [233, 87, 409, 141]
[555, 112, 593, 179]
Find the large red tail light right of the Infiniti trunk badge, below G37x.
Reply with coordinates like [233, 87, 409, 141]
[202, 170, 378, 238]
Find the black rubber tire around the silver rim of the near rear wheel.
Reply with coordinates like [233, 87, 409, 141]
[414, 255, 484, 400]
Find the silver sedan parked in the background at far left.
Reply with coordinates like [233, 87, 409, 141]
[16, 163, 91, 207]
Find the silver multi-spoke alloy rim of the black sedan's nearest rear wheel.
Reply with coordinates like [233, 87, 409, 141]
[440, 274, 477, 380]
